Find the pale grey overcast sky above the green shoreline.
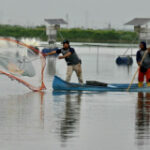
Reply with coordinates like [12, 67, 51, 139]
[0, 0, 150, 28]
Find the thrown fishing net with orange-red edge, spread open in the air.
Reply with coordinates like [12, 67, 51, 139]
[0, 37, 45, 91]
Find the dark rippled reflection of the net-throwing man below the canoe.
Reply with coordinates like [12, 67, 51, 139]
[53, 92, 82, 144]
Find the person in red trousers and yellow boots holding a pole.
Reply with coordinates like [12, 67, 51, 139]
[136, 42, 150, 87]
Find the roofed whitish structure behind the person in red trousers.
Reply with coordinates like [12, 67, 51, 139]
[125, 18, 150, 45]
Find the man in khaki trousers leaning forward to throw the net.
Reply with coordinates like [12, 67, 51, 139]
[44, 40, 83, 84]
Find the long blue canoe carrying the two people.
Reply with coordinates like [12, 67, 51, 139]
[53, 76, 150, 92]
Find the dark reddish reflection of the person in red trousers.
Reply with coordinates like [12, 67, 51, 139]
[136, 93, 150, 146]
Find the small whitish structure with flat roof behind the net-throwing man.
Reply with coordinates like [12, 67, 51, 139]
[45, 19, 68, 44]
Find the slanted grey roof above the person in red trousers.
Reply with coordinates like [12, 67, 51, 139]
[125, 18, 150, 26]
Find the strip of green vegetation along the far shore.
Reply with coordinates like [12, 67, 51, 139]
[0, 25, 138, 44]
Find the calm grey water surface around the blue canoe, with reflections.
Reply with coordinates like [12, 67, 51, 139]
[0, 47, 150, 150]
